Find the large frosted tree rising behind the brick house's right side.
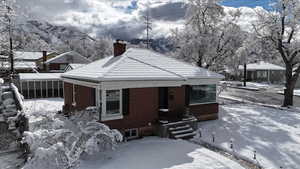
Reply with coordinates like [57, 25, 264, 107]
[173, 0, 245, 70]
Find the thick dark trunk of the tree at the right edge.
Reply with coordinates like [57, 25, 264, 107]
[282, 66, 296, 107]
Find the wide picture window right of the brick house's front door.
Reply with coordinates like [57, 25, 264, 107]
[188, 85, 216, 104]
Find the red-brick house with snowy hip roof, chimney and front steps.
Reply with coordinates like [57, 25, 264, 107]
[61, 41, 224, 138]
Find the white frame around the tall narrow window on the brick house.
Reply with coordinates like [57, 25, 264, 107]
[96, 88, 123, 121]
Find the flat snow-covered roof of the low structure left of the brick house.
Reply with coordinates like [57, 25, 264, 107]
[19, 73, 61, 81]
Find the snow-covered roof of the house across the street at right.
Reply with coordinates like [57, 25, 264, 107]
[239, 61, 285, 70]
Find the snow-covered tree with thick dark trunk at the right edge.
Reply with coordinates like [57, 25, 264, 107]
[254, 0, 300, 106]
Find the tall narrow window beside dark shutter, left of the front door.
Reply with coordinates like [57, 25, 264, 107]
[106, 90, 120, 115]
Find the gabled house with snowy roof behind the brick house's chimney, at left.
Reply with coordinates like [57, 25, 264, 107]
[45, 51, 91, 72]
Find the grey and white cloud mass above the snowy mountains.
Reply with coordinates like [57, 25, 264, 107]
[17, 0, 268, 40]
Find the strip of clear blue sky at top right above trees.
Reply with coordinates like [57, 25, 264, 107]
[222, 0, 277, 10]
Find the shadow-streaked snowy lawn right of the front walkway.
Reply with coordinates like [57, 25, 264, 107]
[199, 104, 300, 169]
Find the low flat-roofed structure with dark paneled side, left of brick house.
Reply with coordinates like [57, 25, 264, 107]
[16, 73, 64, 99]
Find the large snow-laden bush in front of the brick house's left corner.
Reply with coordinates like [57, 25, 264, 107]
[23, 108, 122, 169]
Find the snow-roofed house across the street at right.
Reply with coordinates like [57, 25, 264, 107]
[239, 61, 285, 84]
